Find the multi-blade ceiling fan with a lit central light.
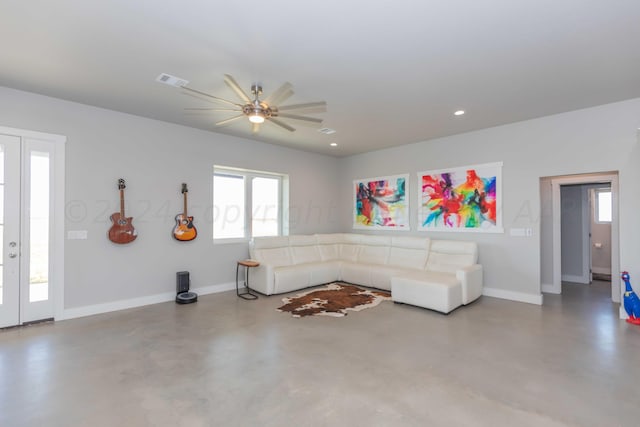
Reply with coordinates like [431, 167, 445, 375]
[181, 74, 327, 133]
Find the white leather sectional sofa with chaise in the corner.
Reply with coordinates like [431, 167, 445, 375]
[249, 233, 482, 313]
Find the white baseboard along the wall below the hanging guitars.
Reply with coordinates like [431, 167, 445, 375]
[61, 282, 236, 320]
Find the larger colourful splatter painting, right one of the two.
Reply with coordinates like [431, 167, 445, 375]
[418, 163, 503, 233]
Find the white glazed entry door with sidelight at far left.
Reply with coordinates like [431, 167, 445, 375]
[0, 128, 64, 327]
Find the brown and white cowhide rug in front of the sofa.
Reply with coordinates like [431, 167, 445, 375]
[277, 283, 391, 317]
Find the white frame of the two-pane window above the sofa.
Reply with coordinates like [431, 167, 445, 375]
[211, 165, 288, 243]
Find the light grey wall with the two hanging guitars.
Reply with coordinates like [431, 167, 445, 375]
[0, 87, 340, 309]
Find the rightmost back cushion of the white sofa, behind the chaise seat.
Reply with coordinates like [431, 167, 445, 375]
[427, 240, 478, 273]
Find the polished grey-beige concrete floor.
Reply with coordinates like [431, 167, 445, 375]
[0, 282, 640, 427]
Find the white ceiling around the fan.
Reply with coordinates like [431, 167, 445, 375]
[0, 0, 640, 156]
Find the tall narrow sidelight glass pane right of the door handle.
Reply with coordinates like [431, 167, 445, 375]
[29, 151, 49, 302]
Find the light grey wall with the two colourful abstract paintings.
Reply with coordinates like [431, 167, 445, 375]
[340, 99, 640, 302]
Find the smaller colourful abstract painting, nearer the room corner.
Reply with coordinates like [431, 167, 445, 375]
[353, 175, 409, 230]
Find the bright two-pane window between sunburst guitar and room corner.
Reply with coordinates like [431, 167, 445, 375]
[213, 166, 287, 240]
